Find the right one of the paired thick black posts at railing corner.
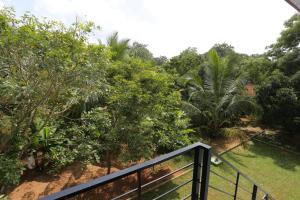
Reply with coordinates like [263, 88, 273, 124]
[200, 147, 211, 200]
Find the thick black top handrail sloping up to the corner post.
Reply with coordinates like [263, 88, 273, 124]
[43, 142, 211, 200]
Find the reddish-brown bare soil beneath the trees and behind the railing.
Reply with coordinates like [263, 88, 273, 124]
[9, 124, 261, 200]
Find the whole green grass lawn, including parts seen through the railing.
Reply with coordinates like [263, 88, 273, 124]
[143, 142, 300, 200]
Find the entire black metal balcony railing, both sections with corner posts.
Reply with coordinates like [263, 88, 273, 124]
[43, 143, 273, 200]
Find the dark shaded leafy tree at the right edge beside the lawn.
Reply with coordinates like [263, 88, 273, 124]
[257, 14, 300, 134]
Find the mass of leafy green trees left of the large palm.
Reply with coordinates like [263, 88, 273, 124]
[0, 9, 191, 186]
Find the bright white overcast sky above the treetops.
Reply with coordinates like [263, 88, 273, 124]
[0, 0, 296, 57]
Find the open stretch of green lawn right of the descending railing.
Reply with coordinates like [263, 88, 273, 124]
[224, 141, 300, 200]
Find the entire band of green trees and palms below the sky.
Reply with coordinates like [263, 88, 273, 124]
[0, 9, 300, 190]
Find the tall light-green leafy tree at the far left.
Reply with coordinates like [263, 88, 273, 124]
[0, 9, 109, 187]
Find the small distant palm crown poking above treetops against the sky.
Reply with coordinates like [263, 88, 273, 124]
[107, 32, 130, 60]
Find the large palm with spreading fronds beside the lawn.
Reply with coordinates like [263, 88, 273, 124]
[185, 50, 257, 136]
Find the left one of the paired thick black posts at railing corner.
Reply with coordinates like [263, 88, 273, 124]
[192, 146, 201, 200]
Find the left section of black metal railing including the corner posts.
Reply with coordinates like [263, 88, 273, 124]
[43, 142, 211, 200]
